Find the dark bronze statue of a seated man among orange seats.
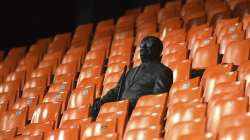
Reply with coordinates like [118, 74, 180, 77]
[92, 37, 173, 118]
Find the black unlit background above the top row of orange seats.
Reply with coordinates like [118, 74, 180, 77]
[0, 0, 165, 50]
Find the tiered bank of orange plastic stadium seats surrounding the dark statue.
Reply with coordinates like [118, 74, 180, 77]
[0, 0, 250, 140]
